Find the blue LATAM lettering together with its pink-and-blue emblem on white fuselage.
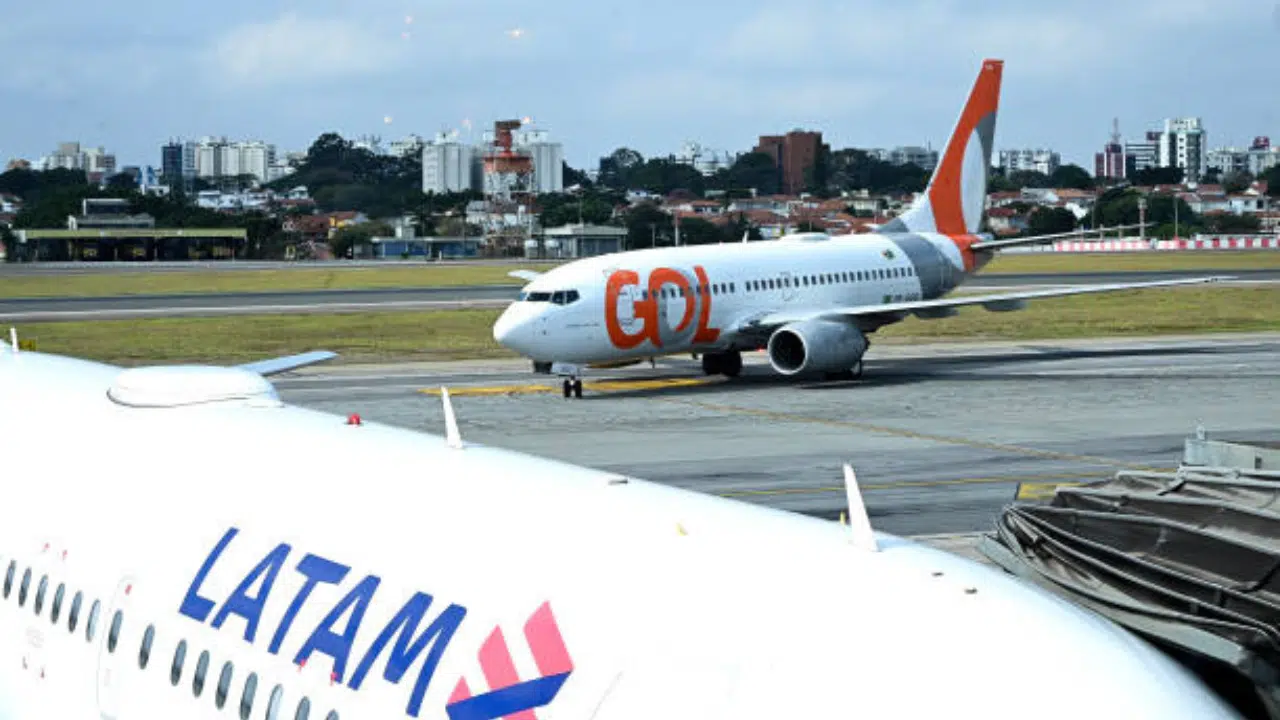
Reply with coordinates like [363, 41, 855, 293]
[178, 528, 573, 720]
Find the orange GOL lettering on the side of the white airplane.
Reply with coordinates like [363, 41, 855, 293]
[604, 265, 719, 350]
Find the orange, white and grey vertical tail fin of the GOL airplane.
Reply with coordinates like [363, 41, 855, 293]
[878, 60, 1005, 236]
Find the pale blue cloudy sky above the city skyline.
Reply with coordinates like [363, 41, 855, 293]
[0, 0, 1280, 172]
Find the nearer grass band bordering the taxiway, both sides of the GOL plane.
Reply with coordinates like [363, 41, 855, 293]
[18, 286, 1280, 365]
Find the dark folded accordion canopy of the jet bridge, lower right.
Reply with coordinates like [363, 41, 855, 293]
[979, 440, 1280, 720]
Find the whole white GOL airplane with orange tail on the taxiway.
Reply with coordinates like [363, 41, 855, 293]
[493, 60, 1220, 397]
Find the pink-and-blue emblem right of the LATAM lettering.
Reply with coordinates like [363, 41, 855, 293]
[445, 602, 573, 720]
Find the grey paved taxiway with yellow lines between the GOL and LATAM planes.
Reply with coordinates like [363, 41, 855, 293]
[276, 333, 1280, 536]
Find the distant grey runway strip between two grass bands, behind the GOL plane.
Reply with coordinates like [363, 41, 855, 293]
[0, 269, 1280, 323]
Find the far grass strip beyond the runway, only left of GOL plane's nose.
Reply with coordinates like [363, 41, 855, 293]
[0, 263, 552, 297]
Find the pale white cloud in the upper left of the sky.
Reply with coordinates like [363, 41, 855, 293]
[205, 13, 407, 88]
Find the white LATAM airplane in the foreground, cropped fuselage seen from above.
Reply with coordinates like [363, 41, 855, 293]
[0, 333, 1236, 720]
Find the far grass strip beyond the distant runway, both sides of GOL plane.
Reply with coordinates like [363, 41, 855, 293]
[0, 251, 1280, 297]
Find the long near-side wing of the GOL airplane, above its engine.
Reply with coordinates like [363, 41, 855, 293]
[736, 275, 1234, 332]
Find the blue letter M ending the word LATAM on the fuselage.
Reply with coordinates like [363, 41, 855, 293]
[351, 592, 467, 717]
